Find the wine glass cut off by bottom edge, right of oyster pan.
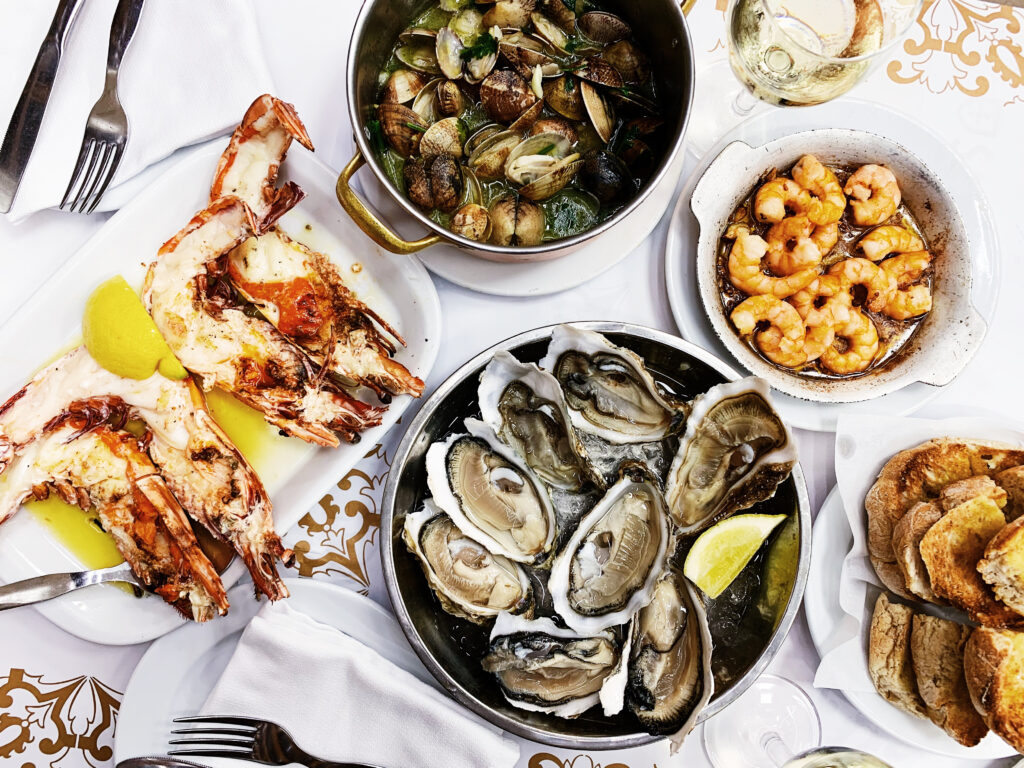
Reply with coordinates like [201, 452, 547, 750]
[703, 675, 891, 768]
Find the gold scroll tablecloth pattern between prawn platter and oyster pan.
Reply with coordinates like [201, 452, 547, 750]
[292, 443, 391, 594]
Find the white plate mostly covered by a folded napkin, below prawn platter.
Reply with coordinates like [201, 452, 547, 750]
[114, 579, 441, 768]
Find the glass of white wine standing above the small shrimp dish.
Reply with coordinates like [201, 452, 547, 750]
[688, 0, 923, 155]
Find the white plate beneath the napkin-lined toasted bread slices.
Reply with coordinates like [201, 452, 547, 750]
[804, 487, 1017, 760]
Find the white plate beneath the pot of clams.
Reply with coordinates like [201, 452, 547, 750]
[360, 147, 686, 296]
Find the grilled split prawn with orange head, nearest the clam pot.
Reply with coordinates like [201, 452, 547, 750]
[210, 95, 423, 402]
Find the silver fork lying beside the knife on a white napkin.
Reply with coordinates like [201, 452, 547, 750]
[60, 0, 142, 213]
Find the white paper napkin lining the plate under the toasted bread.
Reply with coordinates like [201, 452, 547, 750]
[814, 415, 1024, 691]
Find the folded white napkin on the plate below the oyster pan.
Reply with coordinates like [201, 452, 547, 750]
[203, 602, 519, 768]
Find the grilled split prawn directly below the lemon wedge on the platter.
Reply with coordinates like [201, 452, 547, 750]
[0, 347, 292, 599]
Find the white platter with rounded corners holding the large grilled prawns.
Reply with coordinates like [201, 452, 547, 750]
[0, 141, 441, 645]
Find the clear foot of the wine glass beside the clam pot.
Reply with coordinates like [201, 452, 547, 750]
[686, 59, 773, 160]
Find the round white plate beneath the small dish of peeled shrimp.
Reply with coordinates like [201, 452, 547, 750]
[665, 99, 1000, 431]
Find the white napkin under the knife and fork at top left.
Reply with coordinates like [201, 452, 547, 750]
[0, 0, 273, 221]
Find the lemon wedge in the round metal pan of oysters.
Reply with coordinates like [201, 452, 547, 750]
[683, 515, 786, 599]
